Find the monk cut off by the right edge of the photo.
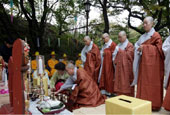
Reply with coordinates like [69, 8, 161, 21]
[162, 36, 170, 111]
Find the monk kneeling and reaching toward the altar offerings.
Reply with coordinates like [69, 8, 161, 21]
[56, 63, 105, 110]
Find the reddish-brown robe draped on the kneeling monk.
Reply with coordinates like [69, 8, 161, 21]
[69, 68, 105, 109]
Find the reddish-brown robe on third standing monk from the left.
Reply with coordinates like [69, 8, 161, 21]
[114, 42, 134, 97]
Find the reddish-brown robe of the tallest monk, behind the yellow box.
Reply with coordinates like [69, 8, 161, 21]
[136, 32, 164, 110]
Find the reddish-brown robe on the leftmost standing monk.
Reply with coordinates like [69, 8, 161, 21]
[84, 43, 101, 83]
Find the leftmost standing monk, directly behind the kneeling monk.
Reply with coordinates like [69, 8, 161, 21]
[81, 36, 101, 83]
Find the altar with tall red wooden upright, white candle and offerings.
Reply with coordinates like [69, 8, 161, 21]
[0, 39, 72, 115]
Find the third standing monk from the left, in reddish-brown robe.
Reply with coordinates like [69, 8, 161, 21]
[112, 31, 134, 97]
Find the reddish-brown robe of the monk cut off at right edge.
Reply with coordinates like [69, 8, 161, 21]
[162, 76, 170, 111]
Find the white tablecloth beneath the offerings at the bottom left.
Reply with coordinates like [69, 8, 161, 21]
[28, 99, 73, 115]
